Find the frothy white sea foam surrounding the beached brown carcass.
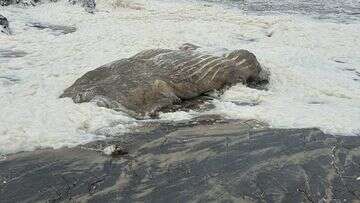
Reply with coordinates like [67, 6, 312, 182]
[0, 0, 360, 153]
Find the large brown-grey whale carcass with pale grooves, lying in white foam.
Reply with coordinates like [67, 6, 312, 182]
[60, 44, 264, 116]
